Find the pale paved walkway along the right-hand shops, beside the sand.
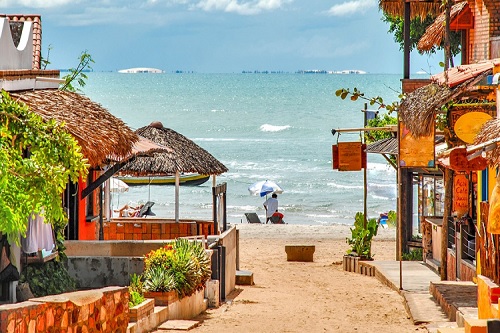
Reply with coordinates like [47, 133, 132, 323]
[370, 261, 457, 332]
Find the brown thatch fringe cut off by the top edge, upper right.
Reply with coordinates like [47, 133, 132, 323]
[379, 0, 441, 19]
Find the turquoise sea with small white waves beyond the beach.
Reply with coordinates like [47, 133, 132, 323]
[84, 73, 408, 225]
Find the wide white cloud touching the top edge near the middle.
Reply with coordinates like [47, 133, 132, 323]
[192, 0, 291, 15]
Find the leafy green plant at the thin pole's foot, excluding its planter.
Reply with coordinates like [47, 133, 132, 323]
[346, 212, 378, 259]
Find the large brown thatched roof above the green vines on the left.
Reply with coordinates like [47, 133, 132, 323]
[10, 90, 139, 167]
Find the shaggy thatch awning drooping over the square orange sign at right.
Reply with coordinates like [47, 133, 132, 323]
[398, 62, 493, 138]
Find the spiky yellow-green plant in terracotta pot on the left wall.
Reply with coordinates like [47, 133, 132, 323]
[142, 239, 212, 305]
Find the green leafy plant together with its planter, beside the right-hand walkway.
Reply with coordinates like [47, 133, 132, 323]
[344, 212, 378, 272]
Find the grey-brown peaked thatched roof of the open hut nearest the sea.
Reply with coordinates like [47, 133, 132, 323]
[120, 122, 228, 175]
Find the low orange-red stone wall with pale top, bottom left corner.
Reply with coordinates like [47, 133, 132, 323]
[0, 287, 129, 333]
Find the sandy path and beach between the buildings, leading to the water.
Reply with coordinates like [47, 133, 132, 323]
[182, 223, 427, 333]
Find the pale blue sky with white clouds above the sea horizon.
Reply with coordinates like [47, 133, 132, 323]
[0, 0, 443, 74]
